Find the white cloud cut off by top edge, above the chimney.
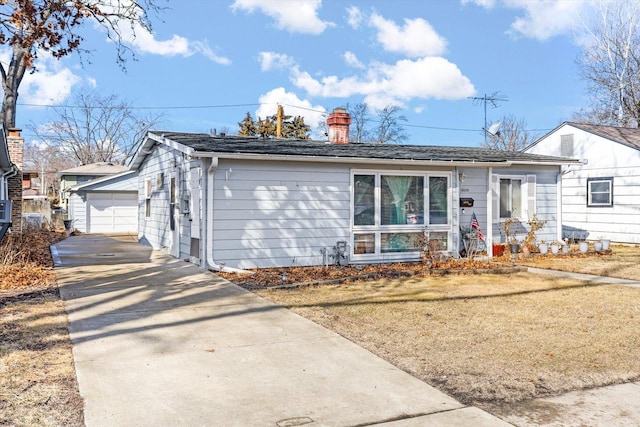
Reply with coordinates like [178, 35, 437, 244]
[231, 0, 335, 35]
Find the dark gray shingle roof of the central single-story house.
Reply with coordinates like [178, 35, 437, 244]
[153, 131, 568, 164]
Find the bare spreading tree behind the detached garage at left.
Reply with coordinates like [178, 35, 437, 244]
[33, 92, 162, 165]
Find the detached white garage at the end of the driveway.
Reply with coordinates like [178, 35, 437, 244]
[67, 171, 138, 234]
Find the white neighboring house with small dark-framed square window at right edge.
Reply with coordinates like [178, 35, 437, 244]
[525, 122, 640, 243]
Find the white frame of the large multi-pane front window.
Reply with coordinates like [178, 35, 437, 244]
[349, 169, 453, 261]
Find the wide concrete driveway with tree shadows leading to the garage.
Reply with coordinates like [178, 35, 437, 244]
[53, 235, 508, 427]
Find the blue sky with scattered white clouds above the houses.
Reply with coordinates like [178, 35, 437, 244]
[5, 0, 590, 146]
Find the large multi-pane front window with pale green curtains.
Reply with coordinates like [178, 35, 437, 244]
[351, 172, 451, 259]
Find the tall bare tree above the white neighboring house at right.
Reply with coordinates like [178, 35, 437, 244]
[578, 0, 640, 127]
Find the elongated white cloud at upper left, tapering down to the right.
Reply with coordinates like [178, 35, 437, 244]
[119, 22, 231, 65]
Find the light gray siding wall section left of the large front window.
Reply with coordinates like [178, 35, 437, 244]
[213, 161, 350, 268]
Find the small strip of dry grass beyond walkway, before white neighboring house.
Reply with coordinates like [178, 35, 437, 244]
[519, 245, 640, 281]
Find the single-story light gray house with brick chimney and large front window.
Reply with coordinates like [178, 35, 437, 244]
[130, 124, 572, 269]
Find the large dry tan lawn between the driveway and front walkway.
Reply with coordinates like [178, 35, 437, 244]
[259, 273, 640, 407]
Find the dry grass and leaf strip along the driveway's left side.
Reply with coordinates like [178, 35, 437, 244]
[0, 229, 84, 426]
